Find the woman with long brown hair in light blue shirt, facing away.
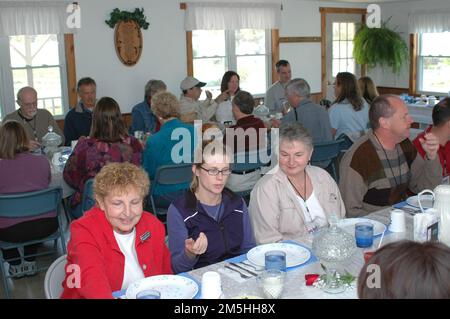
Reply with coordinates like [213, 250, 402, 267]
[328, 72, 369, 140]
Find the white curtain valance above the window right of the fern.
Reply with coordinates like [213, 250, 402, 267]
[408, 9, 450, 33]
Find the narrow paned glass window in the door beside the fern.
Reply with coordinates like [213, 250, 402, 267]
[331, 22, 355, 78]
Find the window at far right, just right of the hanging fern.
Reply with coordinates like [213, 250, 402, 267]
[417, 32, 450, 94]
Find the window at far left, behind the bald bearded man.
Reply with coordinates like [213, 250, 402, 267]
[0, 34, 68, 118]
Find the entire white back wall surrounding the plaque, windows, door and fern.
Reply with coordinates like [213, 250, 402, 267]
[75, 0, 450, 113]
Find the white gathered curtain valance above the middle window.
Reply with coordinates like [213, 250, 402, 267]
[185, 2, 281, 31]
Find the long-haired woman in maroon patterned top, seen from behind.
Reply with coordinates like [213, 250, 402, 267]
[64, 97, 142, 218]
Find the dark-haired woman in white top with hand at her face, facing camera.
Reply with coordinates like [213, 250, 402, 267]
[216, 71, 241, 123]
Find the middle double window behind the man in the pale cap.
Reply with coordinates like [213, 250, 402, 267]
[192, 29, 271, 96]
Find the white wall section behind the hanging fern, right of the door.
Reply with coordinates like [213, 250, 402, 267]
[368, 0, 450, 88]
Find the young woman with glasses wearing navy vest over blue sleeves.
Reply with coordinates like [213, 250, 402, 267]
[167, 142, 255, 273]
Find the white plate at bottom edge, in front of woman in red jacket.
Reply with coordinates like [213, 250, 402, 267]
[126, 275, 198, 299]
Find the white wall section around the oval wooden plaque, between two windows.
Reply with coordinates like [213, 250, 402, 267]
[74, 0, 187, 113]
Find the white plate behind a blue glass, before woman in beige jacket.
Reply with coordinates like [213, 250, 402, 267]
[247, 243, 311, 267]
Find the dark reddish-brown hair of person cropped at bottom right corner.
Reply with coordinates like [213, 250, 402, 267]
[358, 241, 450, 299]
